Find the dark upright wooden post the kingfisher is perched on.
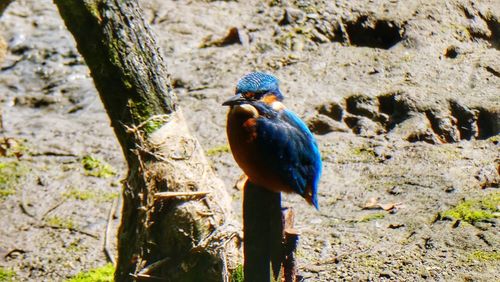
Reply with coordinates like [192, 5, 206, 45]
[243, 181, 283, 282]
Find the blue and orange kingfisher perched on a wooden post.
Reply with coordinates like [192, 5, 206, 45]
[222, 72, 322, 209]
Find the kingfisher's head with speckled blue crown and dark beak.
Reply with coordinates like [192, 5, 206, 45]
[222, 72, 283, 106]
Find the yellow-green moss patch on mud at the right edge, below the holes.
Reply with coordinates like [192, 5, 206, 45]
[442, 192, 500, 223]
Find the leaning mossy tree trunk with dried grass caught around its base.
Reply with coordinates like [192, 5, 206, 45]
[54, 0, 240, 281]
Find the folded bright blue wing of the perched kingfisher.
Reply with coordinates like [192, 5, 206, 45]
[257, 109, 321, 207]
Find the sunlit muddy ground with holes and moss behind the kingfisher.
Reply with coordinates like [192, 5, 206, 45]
[0, 0, 500, 281]
